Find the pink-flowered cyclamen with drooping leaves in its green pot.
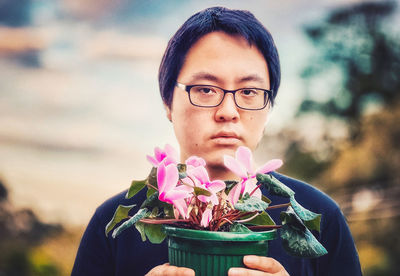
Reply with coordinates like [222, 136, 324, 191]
[105, 145, 327, 275]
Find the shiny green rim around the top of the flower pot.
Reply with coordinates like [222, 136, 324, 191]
[163, 225, 277, 242]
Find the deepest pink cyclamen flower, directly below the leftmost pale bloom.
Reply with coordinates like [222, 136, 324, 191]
[157, 162, 193, 218]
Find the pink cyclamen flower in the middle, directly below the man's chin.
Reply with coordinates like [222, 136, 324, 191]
[186, 166, 226, 205]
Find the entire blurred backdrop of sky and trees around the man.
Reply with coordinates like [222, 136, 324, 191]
[0, 0, 400, 276]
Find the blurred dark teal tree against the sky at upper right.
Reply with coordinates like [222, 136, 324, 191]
[299, 1, 400, 138]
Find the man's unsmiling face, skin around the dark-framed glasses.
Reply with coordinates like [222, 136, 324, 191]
[167, 32, 270, 167]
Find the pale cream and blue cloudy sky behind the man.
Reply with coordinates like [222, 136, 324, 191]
[0, 0, 396, 225]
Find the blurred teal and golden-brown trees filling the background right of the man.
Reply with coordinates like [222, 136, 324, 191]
[280, 1, 400, 276]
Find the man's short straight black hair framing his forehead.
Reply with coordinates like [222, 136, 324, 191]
[158, 7, 281, 107]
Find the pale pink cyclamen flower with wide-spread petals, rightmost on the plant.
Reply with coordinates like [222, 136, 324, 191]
[224, 146, 283, 205]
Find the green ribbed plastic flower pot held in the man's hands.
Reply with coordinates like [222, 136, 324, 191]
[164, 226, 276, 276]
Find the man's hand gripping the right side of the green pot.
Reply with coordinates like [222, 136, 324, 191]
[228, 255, 289, 276]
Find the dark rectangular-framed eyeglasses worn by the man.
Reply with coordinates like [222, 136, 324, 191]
[176, 82, 272, 110]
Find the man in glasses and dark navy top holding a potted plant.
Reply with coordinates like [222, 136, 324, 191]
[72, 7, 361, 276]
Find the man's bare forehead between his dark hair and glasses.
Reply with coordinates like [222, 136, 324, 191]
[178, 32, 269, 86]
